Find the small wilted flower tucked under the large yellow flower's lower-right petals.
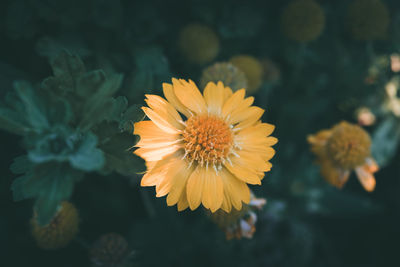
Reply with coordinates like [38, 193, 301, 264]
[208, 194, 267, 240]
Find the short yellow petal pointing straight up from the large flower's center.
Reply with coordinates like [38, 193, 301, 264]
[204, 82, 225, 115]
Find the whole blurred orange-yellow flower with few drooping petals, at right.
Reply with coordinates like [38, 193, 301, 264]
[308, 122, 378, 192]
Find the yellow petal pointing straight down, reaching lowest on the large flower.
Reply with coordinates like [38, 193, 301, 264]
[202, 171, 224, 212]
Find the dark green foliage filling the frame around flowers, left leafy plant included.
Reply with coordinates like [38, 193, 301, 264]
[0, 0, 400, 267]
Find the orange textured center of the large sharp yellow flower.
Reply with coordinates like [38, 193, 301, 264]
[182, 115, 233, 167]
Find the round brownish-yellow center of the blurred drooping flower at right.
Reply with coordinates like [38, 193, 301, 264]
[326, 122, 371, 169]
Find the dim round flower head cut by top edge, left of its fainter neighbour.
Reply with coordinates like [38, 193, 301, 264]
[281, 0, 325, 43]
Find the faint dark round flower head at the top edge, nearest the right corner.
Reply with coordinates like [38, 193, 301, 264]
[348, 0, 390, 41]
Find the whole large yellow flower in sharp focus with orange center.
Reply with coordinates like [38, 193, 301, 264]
[134, 79, 277, 212]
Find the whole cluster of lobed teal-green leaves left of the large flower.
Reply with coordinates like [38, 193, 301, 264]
[0, 52, 143, 225]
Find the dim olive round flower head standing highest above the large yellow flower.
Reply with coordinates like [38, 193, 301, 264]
[179, 24, 219, 64]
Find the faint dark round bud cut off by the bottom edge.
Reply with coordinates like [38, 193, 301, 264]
[89, 233, 130, 267]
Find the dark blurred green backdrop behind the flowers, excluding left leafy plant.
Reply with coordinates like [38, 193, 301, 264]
[0, 0, 400, 267]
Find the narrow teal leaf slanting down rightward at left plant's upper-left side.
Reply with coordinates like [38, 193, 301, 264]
[14, 81, 49, 132]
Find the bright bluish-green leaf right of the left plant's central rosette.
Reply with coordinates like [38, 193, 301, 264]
[69, 133, 105, 171]
